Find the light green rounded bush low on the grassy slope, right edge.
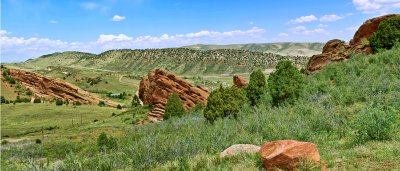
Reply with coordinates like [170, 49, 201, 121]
[354, 108, 399, 143]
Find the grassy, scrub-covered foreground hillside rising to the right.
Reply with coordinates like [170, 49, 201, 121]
[1, 48, 400, 170]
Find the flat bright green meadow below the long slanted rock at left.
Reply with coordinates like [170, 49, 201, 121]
[1, 103, 118, 138]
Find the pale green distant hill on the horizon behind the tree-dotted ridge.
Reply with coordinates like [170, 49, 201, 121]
[183, 42, 324, 56]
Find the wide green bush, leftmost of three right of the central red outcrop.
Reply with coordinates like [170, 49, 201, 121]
[204, 86, 247, 122]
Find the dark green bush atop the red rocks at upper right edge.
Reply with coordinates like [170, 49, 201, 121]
[369, 16, 400, 52]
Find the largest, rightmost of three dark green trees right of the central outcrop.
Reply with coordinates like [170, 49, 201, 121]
[268, 61, 304, 106]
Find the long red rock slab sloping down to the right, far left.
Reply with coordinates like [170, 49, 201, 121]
[10, 68, 118, 107]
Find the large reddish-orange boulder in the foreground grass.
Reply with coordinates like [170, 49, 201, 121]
[260, 140, 320, 170]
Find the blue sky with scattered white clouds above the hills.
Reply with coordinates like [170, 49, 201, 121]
[0, 0, 400, 62]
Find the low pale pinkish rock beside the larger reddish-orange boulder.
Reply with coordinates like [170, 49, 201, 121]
[219, 144, 261, 158]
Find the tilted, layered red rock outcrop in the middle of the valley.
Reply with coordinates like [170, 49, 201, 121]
[139, 69, 210, 120]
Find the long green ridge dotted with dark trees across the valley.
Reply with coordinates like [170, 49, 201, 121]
[15, 48, 309, 75]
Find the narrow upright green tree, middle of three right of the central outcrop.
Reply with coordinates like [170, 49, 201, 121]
[245, 69, 267, 106]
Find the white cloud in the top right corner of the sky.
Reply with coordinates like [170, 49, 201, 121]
[353, 0, 400, 14]
